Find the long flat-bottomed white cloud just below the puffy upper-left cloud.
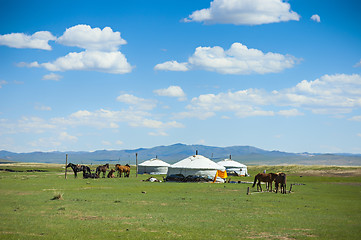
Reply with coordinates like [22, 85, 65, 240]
[40, 51, 132, 74]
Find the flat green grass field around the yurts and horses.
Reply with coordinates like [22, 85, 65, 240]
[0, 165, 361, 239]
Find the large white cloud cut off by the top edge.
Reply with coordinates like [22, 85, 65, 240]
[184, 0, 300, 25]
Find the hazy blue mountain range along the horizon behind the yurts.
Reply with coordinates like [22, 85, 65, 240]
[0, 143, 361, 166]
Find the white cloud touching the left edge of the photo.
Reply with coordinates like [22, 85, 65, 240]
[0, 31, 56, 50]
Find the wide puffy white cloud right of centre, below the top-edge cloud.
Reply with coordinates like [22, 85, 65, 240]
[156, 42, 298, 74]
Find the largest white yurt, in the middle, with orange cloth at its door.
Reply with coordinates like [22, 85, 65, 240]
[167, 155, 226, 178]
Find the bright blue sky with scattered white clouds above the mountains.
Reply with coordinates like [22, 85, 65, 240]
[0, 0, 361, 153]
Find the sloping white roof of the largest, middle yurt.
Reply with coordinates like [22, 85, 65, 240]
[170, 155, 225, 171]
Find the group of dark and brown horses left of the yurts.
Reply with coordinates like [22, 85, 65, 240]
[66, 163, 130, 178]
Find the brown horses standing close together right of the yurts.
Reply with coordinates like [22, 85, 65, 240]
[252, 172, 286, 193]
